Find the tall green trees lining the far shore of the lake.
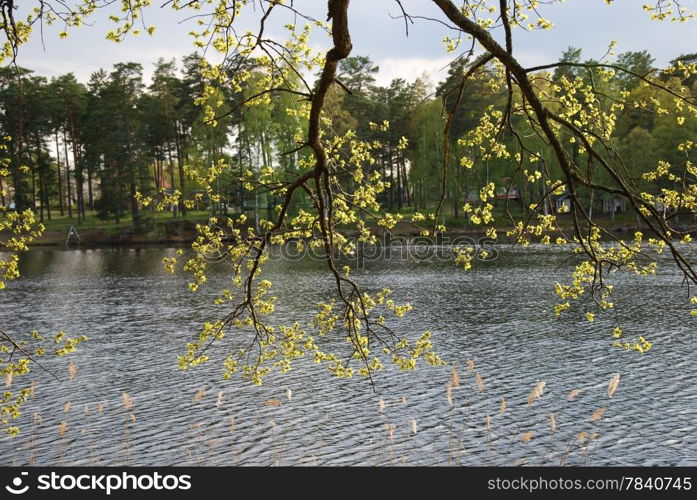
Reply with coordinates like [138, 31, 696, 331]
[0, 48, 697, 226]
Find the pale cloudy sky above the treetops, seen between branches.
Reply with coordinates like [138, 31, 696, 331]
[12, 0, 697, 85]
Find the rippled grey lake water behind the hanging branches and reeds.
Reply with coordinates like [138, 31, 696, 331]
[0, 247, 697, 465]
